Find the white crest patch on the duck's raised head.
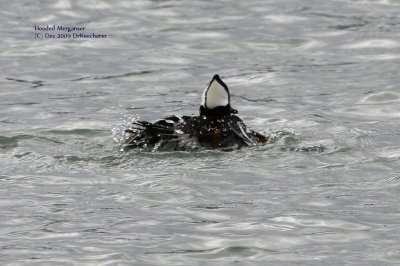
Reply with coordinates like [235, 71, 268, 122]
[201, 79, 229, 109]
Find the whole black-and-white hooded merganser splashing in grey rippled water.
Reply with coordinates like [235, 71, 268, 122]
[124, 75, 268, 151]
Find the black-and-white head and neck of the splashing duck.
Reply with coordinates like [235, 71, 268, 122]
[200, 75, 237, 117]
